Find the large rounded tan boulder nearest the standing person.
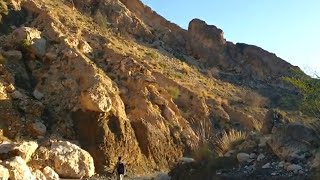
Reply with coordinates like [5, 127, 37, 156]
[50, 141, 95, 178]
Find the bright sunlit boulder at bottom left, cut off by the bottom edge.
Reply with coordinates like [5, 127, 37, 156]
[3, 156, 36, 180]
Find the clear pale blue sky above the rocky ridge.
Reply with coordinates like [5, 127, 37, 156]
[142, 0, 320, 74]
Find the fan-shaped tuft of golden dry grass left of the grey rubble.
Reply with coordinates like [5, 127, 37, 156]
[214, 129, 247, 156]
